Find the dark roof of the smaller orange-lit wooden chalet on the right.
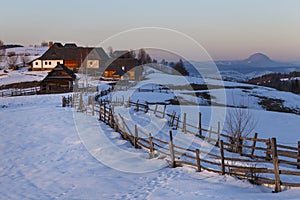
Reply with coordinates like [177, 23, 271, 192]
[105, 58, 139, 71]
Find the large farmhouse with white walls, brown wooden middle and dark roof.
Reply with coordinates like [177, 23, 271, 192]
[30, 43, 108, 73]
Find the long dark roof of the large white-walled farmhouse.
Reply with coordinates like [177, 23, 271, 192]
[38, 43, 108, 61]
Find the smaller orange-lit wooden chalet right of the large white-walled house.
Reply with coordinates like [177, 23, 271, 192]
[103, 51, 141, 80]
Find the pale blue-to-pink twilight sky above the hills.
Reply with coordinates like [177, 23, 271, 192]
[0, 0, 300, 61]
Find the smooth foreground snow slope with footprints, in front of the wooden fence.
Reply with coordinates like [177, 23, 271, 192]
[0, 95, 300, 199]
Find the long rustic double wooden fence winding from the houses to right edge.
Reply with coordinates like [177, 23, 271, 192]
[65, 93, 300, 192]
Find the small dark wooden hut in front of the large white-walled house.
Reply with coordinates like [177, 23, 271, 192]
[40, 64, 76, 94]
